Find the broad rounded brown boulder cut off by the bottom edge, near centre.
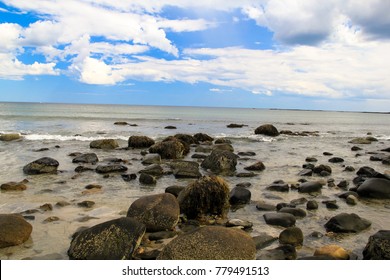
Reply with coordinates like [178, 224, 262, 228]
[157, 226, 256, 260]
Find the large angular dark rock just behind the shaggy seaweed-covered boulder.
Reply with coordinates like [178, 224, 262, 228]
[201, 150, 238, 174]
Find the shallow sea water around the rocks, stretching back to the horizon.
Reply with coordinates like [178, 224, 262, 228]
[0, 103, 390, 259]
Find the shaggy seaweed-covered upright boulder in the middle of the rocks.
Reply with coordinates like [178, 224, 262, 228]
[178, 176, 230, 219]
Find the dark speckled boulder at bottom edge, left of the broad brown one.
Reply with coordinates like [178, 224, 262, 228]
[68, 218, 145, 260]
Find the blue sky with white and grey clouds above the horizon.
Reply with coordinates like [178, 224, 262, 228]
[0, 0, 390, 112]
